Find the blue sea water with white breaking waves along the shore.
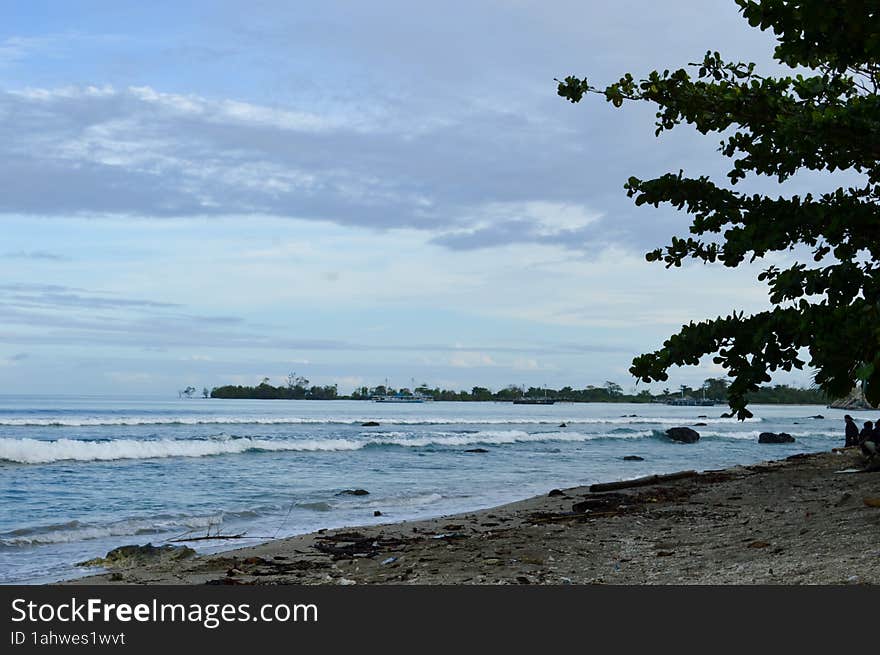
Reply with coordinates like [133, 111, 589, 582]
[0, 396, 876, 584]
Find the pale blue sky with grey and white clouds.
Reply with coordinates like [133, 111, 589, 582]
[0, 0, 832, 397]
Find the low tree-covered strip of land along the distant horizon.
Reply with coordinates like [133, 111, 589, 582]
[203, 373, 829, 405]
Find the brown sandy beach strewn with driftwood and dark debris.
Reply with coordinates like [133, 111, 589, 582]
[69, 449, 880, 585]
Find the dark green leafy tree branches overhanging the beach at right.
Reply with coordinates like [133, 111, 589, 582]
[558, 0, 880, 418]
